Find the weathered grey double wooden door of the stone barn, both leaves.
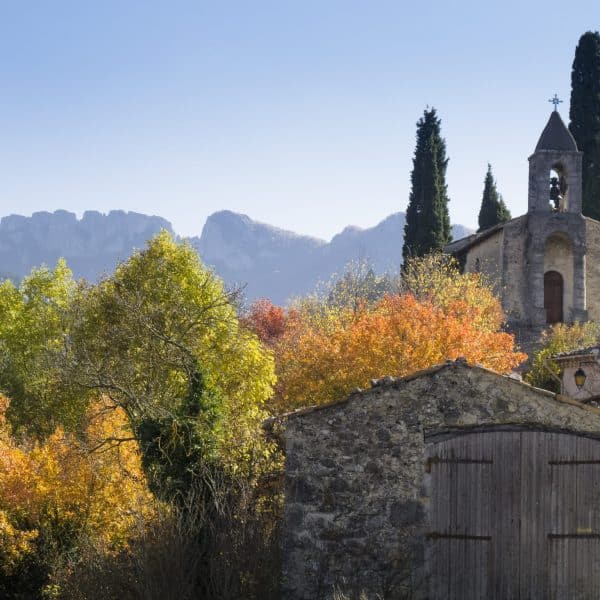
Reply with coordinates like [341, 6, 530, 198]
[427, 431, 600, 600]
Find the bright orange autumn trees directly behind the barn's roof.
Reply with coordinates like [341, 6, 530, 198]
[246, 256, 526, 412]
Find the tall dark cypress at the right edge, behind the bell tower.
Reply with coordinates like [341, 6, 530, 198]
[569, 31, 600, 220]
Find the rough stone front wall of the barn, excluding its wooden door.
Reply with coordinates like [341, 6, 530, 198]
[283, 361, 600, 600]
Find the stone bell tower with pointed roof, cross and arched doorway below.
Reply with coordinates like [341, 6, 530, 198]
[524, 102, 587, 326]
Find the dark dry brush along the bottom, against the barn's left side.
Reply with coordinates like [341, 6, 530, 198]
[58, 472, 281, 600]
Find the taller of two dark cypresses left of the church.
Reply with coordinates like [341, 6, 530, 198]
[402, 108, 452, 262]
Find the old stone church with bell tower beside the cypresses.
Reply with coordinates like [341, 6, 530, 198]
[445, 105, 600, 332]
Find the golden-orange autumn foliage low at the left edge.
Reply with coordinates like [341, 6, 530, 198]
[0, 397, 154, 580]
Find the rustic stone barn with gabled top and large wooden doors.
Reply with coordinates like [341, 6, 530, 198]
[283, 358, 600, 600]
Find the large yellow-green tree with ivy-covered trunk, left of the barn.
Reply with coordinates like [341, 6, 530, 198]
[63, 231, 274, 478]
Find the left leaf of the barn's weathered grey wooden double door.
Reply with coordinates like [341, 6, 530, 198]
[428, 432, 521, 600]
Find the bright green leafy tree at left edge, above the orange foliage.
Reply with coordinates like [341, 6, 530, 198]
[0, 260, 85, 436]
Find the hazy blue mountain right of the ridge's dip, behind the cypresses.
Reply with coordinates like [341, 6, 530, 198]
[190, 211, 472, 303]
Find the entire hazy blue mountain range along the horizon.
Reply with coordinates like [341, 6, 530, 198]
[0, 210, 471, 303]
